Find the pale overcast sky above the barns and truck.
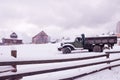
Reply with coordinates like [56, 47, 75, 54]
[0, 0, 120, 42]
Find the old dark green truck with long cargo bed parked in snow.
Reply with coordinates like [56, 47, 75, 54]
[58, 34, 117, 53]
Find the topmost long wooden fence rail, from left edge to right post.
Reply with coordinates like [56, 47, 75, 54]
[0, 54, 108, 66]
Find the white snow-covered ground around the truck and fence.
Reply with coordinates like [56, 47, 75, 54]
[0, 43, 120, 80]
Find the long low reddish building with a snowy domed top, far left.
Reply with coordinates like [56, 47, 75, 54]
[2, 32, 22, 45]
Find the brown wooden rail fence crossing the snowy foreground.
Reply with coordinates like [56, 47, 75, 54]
[0, 51, 120, 80]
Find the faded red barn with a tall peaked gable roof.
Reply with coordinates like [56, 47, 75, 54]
[32, 31, 49, 44]
